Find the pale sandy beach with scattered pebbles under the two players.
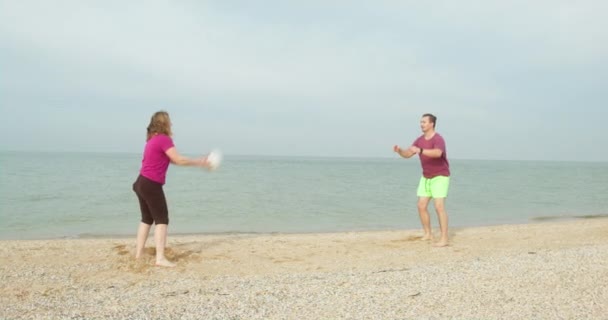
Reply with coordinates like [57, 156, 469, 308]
[0, 218, 608, 319]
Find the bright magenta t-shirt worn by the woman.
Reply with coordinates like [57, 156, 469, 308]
[139, 134, 173, 184]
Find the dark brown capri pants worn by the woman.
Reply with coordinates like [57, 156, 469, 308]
[133, 175, 169, 225]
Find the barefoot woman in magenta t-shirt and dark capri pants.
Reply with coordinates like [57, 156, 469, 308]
[133, 111, 209, 267]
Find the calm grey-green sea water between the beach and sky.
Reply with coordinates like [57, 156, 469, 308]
[0, 152, 608, 239]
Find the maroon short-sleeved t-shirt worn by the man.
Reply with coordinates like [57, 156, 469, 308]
[413, 133, 450, 179]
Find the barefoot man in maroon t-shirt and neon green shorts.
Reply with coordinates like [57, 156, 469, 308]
[393, 113, 450, 247]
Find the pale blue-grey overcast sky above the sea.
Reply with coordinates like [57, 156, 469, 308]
[0, 0, 608, 161]
